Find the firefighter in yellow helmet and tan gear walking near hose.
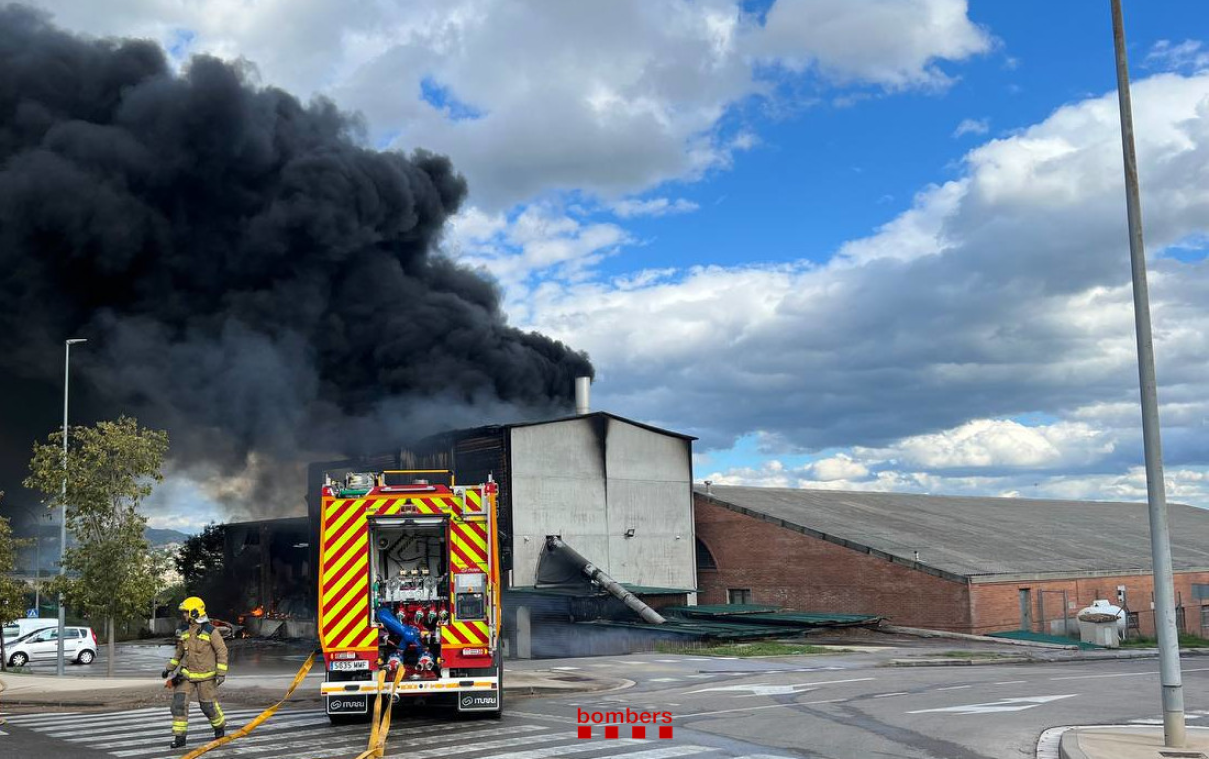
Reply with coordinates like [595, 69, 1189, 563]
[161, 596, 227, 748]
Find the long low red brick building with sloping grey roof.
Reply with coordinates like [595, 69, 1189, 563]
[694, 485, 1209, 636]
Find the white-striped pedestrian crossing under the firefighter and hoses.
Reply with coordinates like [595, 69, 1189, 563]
[4, 706, 802, 759]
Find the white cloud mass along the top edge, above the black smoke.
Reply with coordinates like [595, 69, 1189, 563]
[25, 0, 990, 210]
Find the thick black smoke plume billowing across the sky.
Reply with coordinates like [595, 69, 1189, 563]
[0, 6, 591, 519]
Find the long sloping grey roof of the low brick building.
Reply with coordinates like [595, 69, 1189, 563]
[695, 485, 1209, 579]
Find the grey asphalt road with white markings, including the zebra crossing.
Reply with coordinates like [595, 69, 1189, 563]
[0, 654, 1209, 759]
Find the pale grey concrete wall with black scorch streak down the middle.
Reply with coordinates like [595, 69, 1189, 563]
[510, 416, 695, 589]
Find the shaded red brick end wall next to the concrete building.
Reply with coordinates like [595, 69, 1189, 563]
[694, 497, 970, 632]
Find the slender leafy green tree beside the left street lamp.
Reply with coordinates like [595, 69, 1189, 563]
[25, 417, 168, 676]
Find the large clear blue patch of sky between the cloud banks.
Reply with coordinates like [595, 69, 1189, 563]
[602, 0, 1209, 273]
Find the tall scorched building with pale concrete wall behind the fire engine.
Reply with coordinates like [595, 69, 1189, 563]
[308, 412, 696, 657]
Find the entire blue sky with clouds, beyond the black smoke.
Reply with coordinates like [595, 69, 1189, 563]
[21, 0, 1209, 527]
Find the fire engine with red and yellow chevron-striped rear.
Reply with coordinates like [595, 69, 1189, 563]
[319, 470, 503, 724]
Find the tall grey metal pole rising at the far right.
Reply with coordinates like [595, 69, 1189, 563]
[1112, 0, 1186, 748]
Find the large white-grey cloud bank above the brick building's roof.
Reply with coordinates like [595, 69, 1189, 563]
[523, 75, 1209, 494]
